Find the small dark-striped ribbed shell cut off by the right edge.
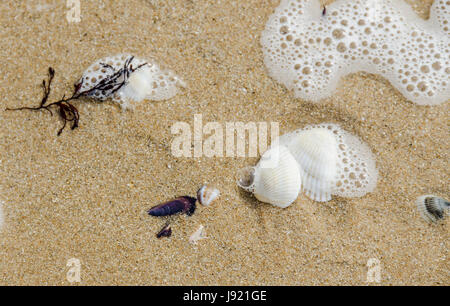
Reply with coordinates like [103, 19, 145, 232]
[416, 194, 450, 223]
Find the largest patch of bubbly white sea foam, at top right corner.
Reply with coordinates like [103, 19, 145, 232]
[261, 0, 450, 105]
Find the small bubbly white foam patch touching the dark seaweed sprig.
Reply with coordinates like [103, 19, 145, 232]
[79, 54, 186, 108]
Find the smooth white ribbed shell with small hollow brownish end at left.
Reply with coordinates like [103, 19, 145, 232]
[237, 146, 301, 208]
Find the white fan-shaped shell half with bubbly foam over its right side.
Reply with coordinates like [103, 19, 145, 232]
[278, 123, 378, 202]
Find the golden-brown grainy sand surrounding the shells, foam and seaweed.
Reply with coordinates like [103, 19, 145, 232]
[0, 0, 450, 285]
